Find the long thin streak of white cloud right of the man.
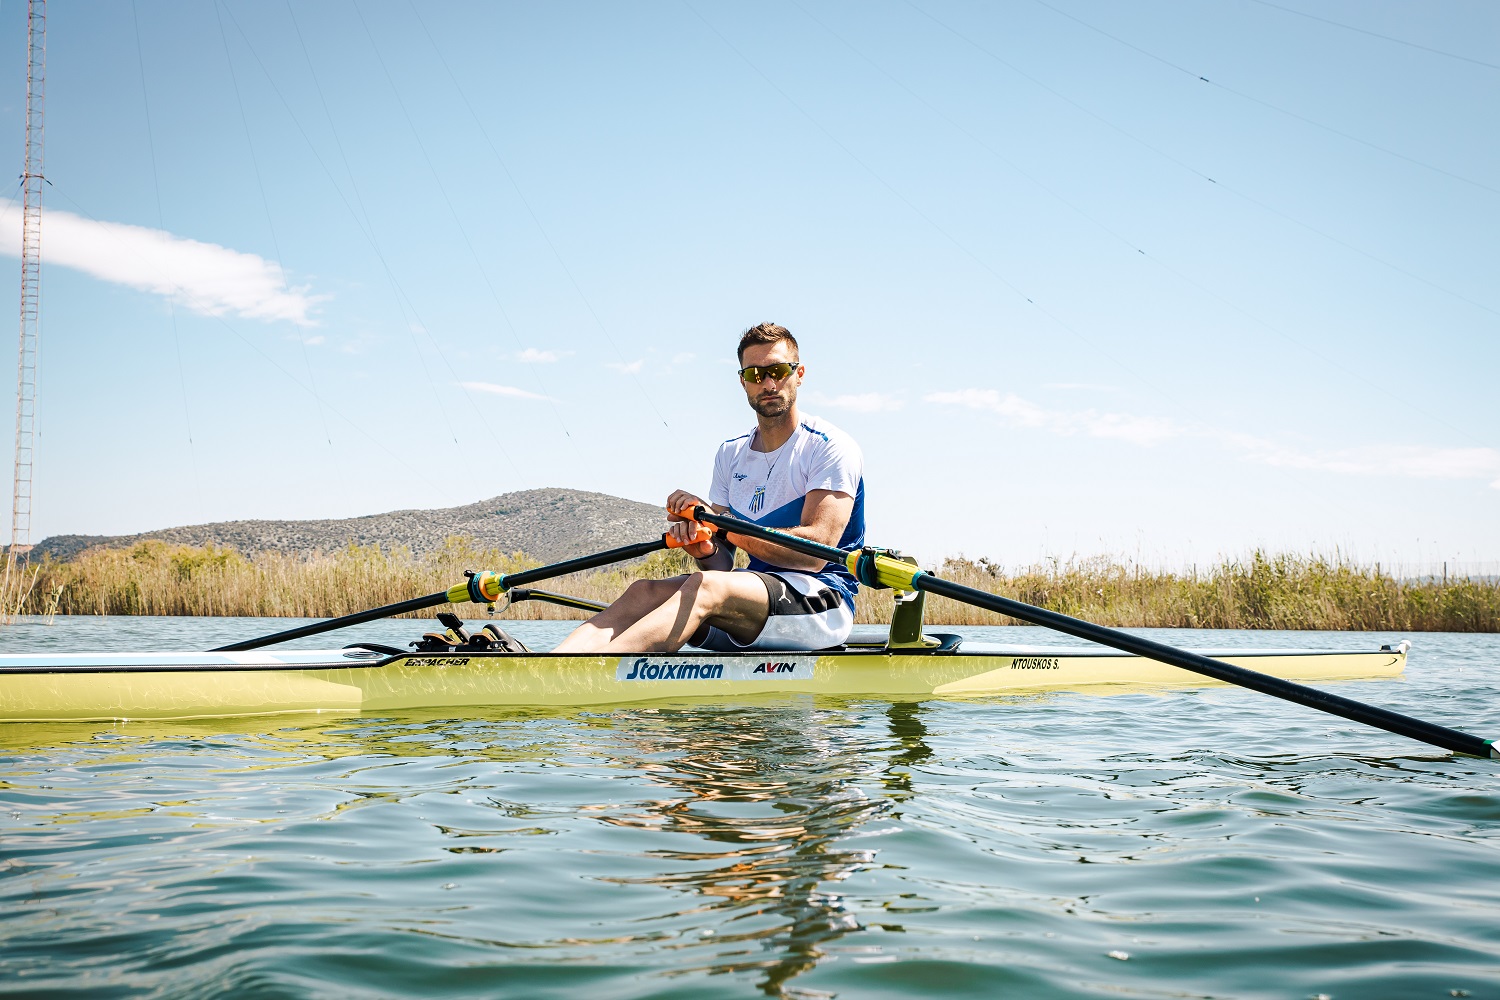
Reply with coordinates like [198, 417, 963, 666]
[923, 388, 1500, 489]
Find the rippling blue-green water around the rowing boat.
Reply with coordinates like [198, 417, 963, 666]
[0, 619, 1500, 1000]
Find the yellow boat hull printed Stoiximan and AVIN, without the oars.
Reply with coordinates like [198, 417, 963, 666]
[0, 636, 1407, 721]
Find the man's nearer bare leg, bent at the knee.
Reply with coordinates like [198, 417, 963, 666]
[603, 570, 771, 652]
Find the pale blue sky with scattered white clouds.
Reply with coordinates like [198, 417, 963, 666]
[0, 0, 1500, 571]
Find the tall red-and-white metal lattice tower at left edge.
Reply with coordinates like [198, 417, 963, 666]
[11, 0, 47, 562]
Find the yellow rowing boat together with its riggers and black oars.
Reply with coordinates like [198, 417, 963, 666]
[0, 507, 1482, 759]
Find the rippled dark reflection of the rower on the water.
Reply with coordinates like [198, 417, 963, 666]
[602, 706, 911, 997]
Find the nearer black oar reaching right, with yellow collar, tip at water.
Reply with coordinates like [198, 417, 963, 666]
[678, 507, 1500, 759]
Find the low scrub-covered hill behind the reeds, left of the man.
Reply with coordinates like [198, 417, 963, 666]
[33, 489, 666, 562]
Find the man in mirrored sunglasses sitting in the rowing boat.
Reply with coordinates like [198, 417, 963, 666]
[557, 322, 864, 652]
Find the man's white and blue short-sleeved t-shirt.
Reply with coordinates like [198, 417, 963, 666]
[708, 415, 864, 607]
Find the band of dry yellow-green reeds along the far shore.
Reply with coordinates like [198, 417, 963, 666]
[6, 538, 1500, 633]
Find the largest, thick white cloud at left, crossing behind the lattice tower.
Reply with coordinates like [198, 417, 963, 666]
[0, 205, 329, 327]
